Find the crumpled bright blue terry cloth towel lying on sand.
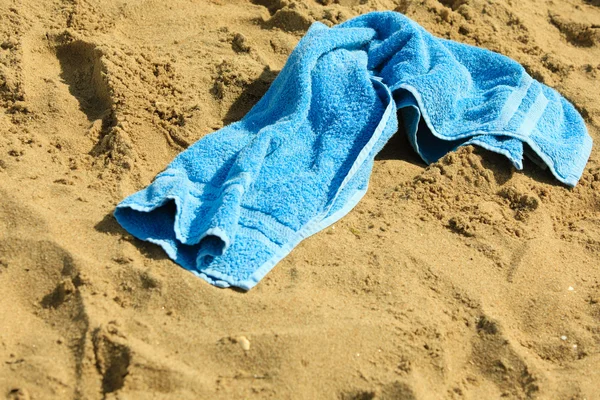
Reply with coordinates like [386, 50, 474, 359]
[115, 12, 592, 290]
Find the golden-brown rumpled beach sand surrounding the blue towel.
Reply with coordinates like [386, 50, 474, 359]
[0, 0, 600, 400]
